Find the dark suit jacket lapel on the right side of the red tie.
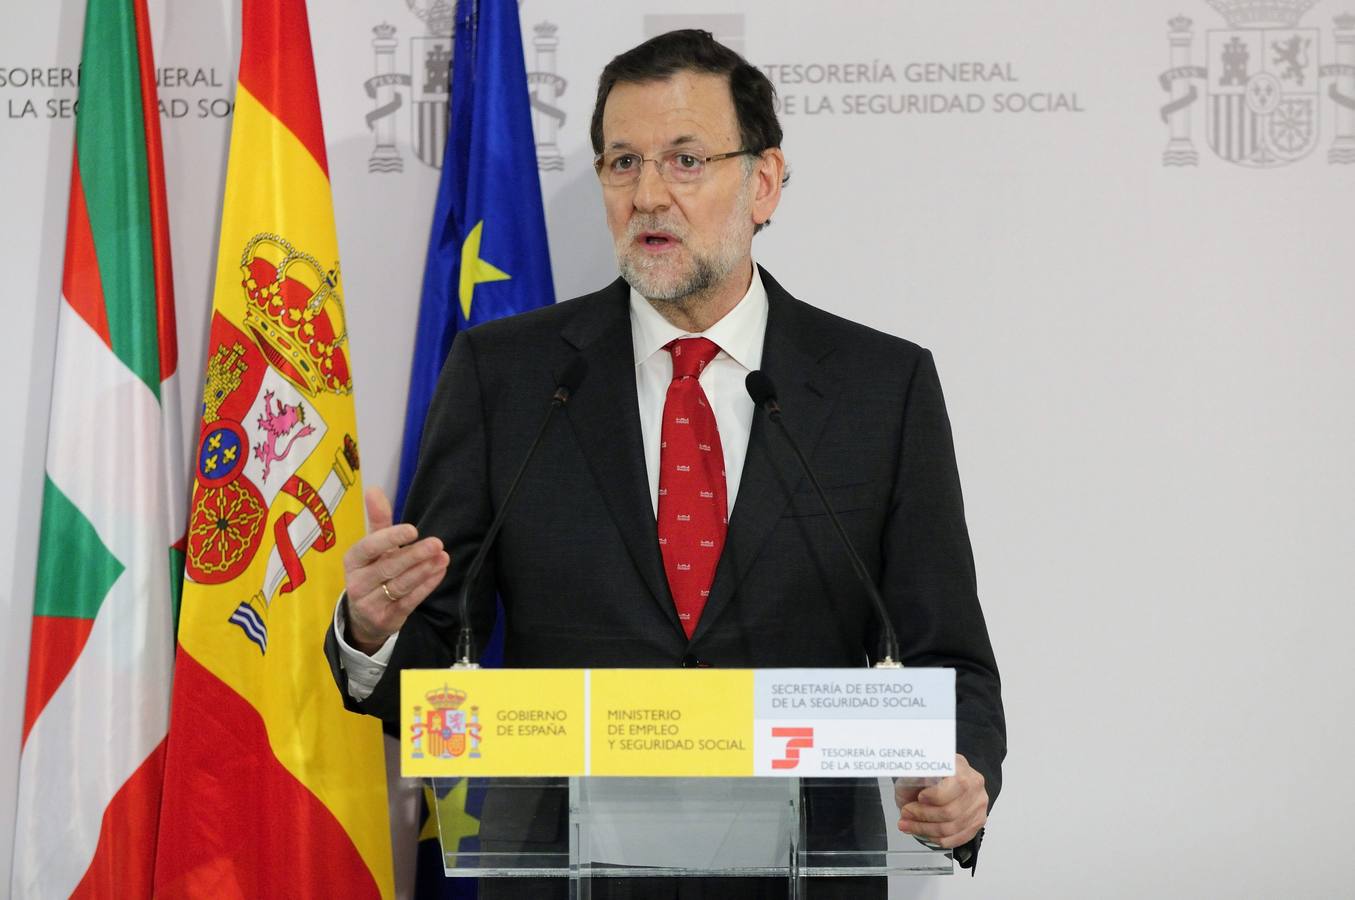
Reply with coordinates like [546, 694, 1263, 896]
[692, 270, 839, 641]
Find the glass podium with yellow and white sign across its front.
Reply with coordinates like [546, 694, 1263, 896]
[401, 670, 954, 899]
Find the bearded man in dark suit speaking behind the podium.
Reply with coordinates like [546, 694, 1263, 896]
[327, 31, 1005, 897]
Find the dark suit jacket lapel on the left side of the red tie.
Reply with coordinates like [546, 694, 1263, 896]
[561, 279, 686, 640]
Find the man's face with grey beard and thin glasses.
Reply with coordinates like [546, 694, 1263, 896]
[602, 72, 770, 305]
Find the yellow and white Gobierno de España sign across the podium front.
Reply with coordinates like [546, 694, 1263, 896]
[400, 668, 955, 778]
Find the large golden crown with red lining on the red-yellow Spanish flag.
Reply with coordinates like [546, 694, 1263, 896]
[240, 234, 352, 397]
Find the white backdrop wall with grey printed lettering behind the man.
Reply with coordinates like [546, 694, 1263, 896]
[0, 0, 1355, 897]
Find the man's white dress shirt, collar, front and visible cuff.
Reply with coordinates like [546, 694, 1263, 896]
[335, 266, 767, 701]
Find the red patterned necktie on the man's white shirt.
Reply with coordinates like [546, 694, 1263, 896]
[659, 338, 729, 637]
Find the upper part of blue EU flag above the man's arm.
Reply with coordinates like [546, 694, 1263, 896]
[396, 0, 556, 522]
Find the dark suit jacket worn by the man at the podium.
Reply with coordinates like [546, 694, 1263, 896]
[327, 271, 1005, 872]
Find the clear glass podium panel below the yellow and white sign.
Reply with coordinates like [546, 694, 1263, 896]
[430, 777, 954, 878]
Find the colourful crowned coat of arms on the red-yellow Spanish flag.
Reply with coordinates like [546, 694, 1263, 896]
[186, 234, 358, 653]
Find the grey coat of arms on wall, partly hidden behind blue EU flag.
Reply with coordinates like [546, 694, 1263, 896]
[363, 0, 566, 173]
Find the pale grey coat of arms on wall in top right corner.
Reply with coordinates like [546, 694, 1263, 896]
[1159, 0, 1355, 168]
